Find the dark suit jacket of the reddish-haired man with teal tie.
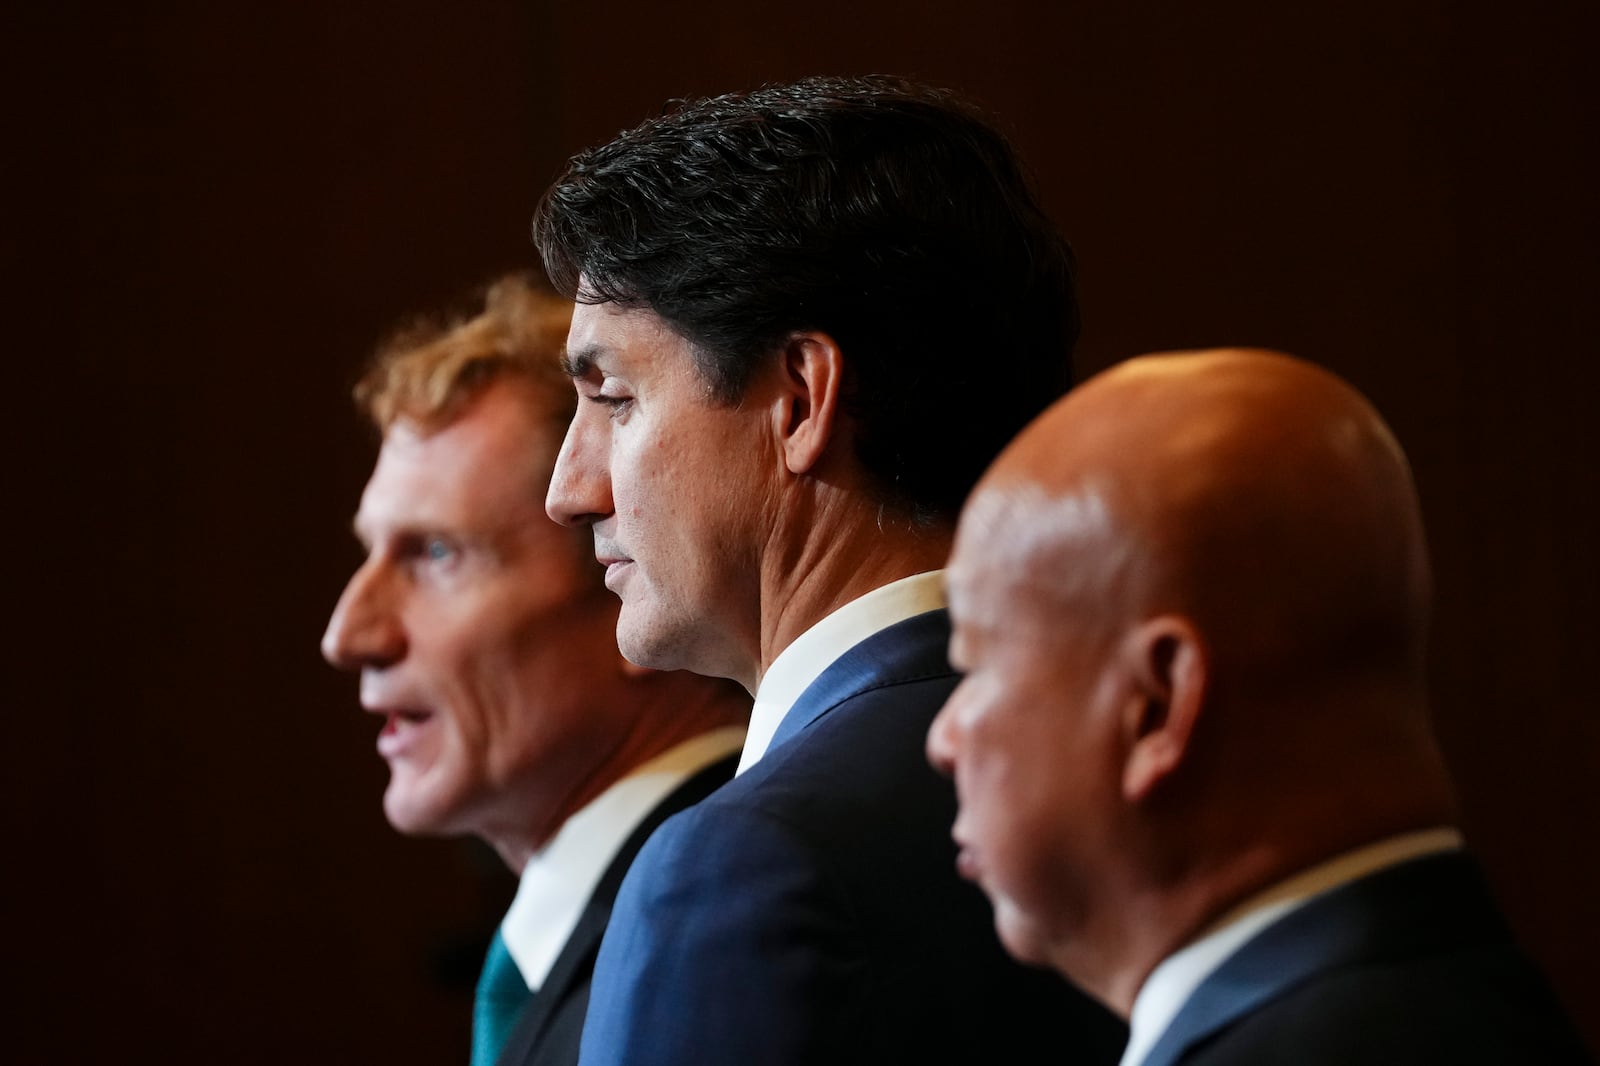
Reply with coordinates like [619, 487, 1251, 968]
[496, 755, 739, 1066]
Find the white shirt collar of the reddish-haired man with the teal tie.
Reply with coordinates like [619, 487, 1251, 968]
[501, 727, 744, 992]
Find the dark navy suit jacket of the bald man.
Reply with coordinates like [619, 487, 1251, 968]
[1144, 853, 1590, 1066]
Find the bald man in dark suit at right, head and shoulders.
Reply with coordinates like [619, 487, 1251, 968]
[928, 351, 1589, 1066]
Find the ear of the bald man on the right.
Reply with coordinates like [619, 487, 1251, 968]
[1120, 615, 1210, 804]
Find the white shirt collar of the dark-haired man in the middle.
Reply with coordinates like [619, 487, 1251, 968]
[739, 570, 944, 773]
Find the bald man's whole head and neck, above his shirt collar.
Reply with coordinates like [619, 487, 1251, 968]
[928, 351, 1450, 1004]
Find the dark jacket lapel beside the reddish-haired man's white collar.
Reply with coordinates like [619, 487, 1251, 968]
[498, 755, 739, 1066]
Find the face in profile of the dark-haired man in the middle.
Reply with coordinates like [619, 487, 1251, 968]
[547, 303, 782, 677]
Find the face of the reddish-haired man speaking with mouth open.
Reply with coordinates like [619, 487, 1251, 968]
[322, 378, 630, 842]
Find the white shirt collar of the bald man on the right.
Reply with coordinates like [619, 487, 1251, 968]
[1120, 828, 1462, 1066]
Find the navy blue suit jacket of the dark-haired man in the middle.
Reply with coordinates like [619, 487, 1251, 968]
[581, 611, 1126, 1066]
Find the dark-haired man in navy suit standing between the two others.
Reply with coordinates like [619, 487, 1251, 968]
[534, 78, 1123, 1066]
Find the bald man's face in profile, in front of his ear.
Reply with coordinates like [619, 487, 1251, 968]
[928, 490, 1126, 968]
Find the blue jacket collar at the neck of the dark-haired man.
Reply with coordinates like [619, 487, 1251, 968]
[768, 610, 950, 751]
